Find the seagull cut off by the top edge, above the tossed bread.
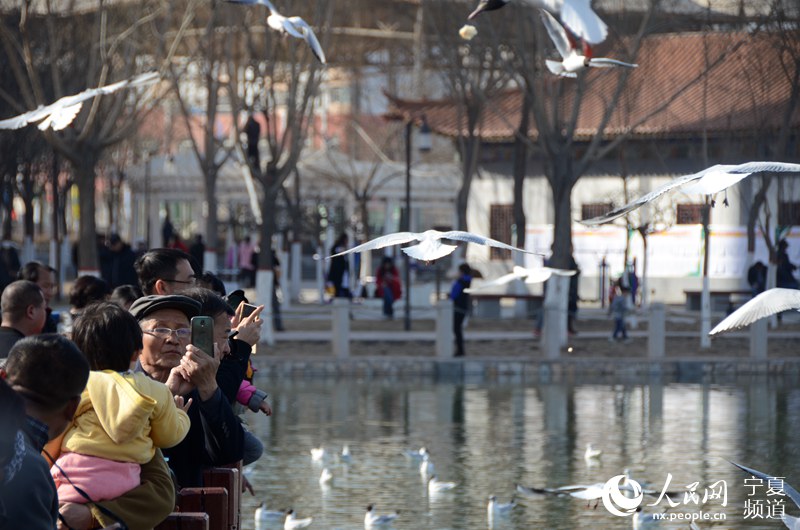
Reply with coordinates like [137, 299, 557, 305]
[467, 0, 608, 44]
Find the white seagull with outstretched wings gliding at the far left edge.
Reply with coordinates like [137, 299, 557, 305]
[0, 72, 159, 131]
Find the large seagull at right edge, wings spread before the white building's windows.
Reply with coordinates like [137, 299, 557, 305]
[580, 162, 800, 225]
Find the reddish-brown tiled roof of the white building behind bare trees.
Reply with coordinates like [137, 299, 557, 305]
[387, 32, 800, 141]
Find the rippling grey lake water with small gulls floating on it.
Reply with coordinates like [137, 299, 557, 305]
[242, 377, 800, 530]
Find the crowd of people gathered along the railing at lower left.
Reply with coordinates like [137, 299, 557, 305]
[0, 243, 272, 530]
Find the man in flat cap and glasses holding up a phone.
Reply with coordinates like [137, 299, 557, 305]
[130, 295, 244, 487]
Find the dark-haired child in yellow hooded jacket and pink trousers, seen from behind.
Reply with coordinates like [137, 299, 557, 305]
[51, 302, 191, 504]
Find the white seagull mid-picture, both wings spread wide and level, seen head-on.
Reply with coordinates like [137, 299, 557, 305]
[316, 230, 541, 261]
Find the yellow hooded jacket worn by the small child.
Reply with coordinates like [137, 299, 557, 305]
[61, 370, 189, 464]
